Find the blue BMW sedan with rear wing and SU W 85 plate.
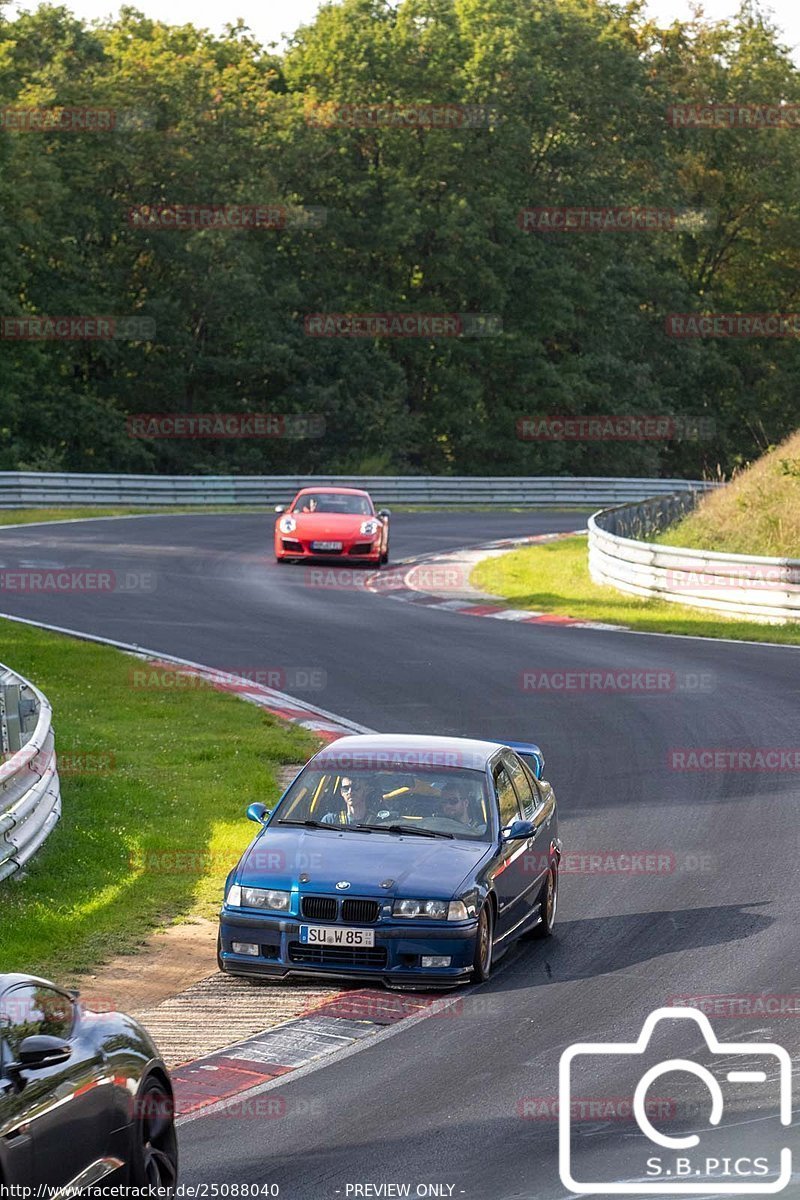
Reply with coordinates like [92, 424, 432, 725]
[218, 734, 561, 988]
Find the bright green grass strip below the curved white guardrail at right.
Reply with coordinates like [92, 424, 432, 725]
[471, 538, 800, 646]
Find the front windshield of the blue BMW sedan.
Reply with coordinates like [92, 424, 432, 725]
[276, 768, 492, 841]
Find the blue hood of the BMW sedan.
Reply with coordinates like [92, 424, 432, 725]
[236, 824, 491, 899]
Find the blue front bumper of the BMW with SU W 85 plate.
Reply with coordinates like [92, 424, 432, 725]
[219, 908, 477, 986]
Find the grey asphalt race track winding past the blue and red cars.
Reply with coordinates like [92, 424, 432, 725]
[0, 512, 800, 1200]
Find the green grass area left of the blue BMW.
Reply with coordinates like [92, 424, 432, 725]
[0, 620, 318, 980]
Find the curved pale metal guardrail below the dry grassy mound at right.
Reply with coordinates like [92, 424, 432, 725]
[589, 491, 800, 624]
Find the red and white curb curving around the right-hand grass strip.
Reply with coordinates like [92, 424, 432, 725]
[366, 529, 625, 630]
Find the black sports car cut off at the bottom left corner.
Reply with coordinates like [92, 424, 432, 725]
[0, 974, 178, 1195]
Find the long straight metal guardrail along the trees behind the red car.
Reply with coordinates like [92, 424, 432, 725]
[0, 470, 714, 509]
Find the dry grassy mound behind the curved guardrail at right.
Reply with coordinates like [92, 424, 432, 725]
[655, 432, 800, 558]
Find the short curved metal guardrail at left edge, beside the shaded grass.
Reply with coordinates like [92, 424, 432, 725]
[0, 664, 61, 881]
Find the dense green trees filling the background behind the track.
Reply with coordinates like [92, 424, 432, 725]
[0, 0, 800, 475]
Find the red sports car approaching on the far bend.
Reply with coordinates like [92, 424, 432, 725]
[275, 487, 390, 565]
